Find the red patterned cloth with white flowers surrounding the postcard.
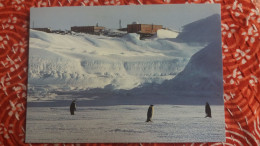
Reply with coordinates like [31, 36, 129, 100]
[0, 0, 260, 146]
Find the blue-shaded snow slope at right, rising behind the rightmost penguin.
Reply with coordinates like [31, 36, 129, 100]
[163, 42, 223, 91]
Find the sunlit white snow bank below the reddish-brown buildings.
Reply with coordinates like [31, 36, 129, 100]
[29, 30, 202, 89]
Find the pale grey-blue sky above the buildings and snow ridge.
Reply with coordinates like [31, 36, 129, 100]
[30, 4, 221, 31]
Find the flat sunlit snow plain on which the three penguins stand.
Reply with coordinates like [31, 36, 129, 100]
[26, 105, 225, 143]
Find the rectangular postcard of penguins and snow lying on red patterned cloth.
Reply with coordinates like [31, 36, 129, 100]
[26, 4, 225, 143]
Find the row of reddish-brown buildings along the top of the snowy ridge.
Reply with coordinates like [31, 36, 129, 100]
[32, 23, 167, 39]
